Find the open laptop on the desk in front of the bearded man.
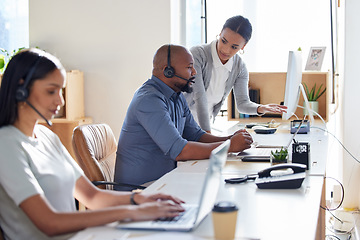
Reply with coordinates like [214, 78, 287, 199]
[238, 118, 306, 162]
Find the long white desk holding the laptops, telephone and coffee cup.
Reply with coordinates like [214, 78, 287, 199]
[70, 123, 327, 240]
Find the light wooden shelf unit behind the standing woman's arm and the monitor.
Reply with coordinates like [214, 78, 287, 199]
[228, 72, 330, 121]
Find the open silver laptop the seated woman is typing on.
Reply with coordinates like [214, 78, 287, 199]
[117, 140, 230, 232]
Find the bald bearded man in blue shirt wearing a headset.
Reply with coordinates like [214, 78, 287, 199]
[115, 45, 252, 190]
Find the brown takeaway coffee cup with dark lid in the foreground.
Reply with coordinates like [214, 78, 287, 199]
[212, 201, 238, 240]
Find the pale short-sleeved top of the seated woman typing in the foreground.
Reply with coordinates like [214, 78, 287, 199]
[0, 125, 83, 240]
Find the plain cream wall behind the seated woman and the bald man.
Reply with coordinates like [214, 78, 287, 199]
[29, 0, 171, 139]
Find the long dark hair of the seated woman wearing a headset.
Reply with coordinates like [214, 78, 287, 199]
[0, 48, 64, 127]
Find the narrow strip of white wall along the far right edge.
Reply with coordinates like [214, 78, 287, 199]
[341, 0, 360, 208]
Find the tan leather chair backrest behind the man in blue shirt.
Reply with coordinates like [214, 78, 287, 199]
[72, 123, 117, 189]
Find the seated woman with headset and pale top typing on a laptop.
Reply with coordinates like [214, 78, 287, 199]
[0, 49, 183, 240]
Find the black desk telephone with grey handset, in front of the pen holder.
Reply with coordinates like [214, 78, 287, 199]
[255, 163, 306, 189]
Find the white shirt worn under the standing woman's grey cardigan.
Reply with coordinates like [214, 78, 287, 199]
[206, 40, 234, 121]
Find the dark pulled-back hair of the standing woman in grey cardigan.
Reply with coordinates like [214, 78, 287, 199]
[222, 15, 252, 42]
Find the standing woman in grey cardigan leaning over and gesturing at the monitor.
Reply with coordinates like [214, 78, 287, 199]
[185, 16, 286, 132]
